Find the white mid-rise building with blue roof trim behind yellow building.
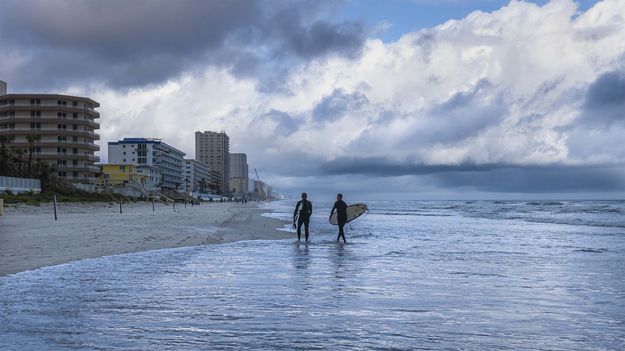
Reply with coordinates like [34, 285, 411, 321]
[108, 138, 185, 189]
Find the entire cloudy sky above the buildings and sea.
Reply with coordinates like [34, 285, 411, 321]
[0, 0, 625, 200]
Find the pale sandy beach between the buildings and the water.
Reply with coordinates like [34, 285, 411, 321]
[0, 203, 290, 275]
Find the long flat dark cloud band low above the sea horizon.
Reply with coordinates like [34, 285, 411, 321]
[321, 157, 625, 193]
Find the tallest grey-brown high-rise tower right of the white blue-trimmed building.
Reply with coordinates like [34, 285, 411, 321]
[195, 131, 230, 195]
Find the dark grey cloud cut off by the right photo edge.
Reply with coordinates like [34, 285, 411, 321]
[582, 71, 625, 126]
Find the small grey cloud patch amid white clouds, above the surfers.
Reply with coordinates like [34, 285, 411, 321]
[313, 89, 369, 121]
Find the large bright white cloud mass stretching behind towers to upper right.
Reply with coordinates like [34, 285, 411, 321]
[63, 0, 625, 195]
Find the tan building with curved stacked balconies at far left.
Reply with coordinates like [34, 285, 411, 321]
[0, 81, 100, 185]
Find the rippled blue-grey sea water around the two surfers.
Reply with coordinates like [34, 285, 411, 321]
[0, 201, 625, 350]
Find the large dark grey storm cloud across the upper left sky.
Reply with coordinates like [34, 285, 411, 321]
[0, 0, 364, 89]
